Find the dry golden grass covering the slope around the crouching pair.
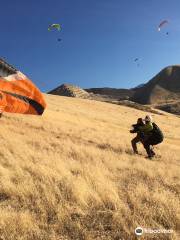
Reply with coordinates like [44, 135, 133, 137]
[0, 95, 180, 240]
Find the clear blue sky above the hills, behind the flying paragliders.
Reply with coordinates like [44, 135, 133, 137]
[0, 0, 180, 91]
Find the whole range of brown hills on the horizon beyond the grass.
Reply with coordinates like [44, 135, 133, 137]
[48, 65, 180, 114]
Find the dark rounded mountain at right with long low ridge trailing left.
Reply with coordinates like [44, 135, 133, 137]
[86, 65, 180, 104]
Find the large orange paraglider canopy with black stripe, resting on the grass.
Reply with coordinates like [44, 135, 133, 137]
[0, 60, 46, 115]
